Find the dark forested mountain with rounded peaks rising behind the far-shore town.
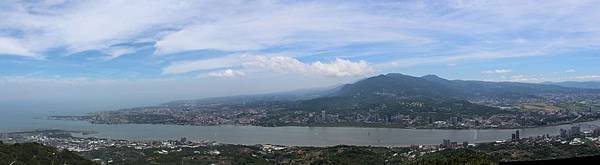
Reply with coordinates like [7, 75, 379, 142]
[284, 73, 600, 116]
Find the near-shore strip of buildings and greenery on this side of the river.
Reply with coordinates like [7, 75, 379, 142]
[0, 126, 600, 164]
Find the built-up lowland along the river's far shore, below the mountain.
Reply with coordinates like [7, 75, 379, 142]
[49, 92, 600, 129]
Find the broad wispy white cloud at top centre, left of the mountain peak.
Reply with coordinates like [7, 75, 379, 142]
[156, 1, 430, 54]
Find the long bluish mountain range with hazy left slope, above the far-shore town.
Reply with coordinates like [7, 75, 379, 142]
[166, 73, 600, 105]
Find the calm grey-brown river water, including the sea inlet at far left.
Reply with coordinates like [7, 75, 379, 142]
[0, 109, 600, 146]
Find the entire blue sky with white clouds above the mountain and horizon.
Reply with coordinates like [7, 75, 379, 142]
[0, 0, 600, 110]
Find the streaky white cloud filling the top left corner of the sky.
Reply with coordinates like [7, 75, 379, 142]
[0, 0, 204, 56]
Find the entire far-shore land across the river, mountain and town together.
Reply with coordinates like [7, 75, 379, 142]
[50, 74, 600, 129]
